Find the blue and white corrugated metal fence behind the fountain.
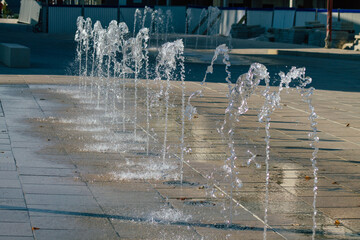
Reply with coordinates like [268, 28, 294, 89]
[45, 5, 360, 36]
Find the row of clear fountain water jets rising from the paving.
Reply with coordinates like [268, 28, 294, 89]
[69, 14, 319, 239]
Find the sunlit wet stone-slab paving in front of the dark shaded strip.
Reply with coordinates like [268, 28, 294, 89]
[0, 75, 360, 239]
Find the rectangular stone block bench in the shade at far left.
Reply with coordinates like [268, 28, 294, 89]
[0, 43, 30, 68]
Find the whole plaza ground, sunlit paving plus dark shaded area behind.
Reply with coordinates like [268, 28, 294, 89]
[0, 22, 360, 239]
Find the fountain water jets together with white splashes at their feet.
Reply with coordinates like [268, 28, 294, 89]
[70, 16, 319, 236]
